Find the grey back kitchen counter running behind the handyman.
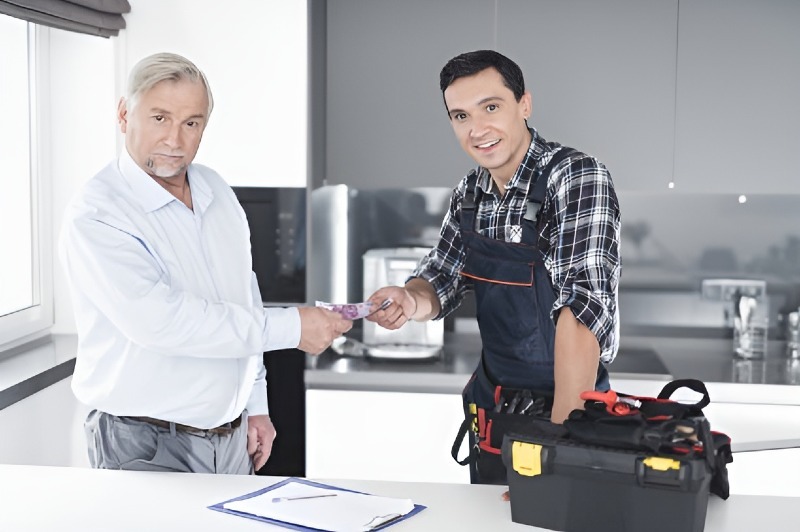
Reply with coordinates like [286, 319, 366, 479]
[305, 331, 800, 405]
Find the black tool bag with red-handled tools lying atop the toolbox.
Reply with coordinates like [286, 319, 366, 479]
[564, 379, 733, 499]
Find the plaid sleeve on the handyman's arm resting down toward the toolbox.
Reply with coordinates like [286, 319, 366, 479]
[539, 154, 620, 362]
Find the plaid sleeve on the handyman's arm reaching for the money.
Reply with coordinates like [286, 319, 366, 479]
[412, 177, 472, 320]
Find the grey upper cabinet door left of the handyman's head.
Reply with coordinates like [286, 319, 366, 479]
[324, 0, 495, 188]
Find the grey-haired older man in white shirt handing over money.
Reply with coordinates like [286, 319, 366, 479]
[60, 54, 352, 474]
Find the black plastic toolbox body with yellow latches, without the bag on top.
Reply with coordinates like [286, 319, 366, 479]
[503, 428, 711, 532]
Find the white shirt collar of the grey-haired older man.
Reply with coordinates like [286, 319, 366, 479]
[118, 149, 214, 214]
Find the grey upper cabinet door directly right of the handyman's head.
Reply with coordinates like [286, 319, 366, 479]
[497, 0, 678, 192]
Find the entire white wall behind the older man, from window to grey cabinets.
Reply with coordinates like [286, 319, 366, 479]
[51, 0, 308, 333]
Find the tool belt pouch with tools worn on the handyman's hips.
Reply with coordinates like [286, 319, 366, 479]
[451, 386, 562, 465]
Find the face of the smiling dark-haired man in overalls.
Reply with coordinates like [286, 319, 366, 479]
[444, 68, 531, 183]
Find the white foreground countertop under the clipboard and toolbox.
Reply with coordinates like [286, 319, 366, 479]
[0, 449, 800, 532]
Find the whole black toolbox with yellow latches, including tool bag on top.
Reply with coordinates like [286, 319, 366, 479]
[502, 379, 732, 532]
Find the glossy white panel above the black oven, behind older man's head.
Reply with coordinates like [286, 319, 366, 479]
[117, 0, 308, 187]
